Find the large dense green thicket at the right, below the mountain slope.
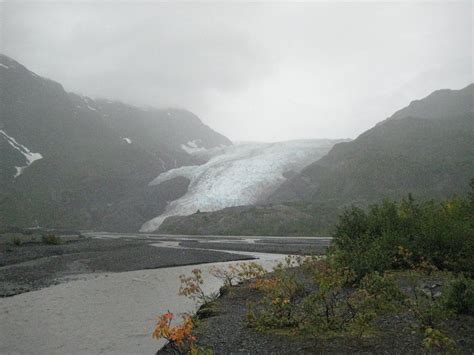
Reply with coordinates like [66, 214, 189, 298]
[329, 183, 474, 280]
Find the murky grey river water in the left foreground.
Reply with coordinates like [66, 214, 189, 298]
[0, 243, 285, 354]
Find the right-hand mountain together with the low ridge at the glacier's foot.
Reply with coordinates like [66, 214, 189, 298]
[159, 85, 474, 235]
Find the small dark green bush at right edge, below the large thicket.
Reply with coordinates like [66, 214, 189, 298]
[443, 276, 474, 314]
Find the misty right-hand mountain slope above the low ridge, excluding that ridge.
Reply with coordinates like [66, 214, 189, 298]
[269, 85, 474, 204]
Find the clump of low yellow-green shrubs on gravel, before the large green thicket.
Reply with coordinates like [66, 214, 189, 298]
[247, 259, 404, 337]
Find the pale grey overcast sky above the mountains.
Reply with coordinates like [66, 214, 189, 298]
[0, 1, 473, 141]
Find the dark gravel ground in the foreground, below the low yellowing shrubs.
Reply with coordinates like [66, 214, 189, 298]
[159, 278, 474, 354]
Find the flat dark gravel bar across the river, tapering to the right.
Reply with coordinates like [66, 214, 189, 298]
[0, 238, 249, 297]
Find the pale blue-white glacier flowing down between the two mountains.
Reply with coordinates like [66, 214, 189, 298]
[140, 139, 339, 232]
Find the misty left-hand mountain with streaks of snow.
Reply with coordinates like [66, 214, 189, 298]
[0, 55, 232, 231]
